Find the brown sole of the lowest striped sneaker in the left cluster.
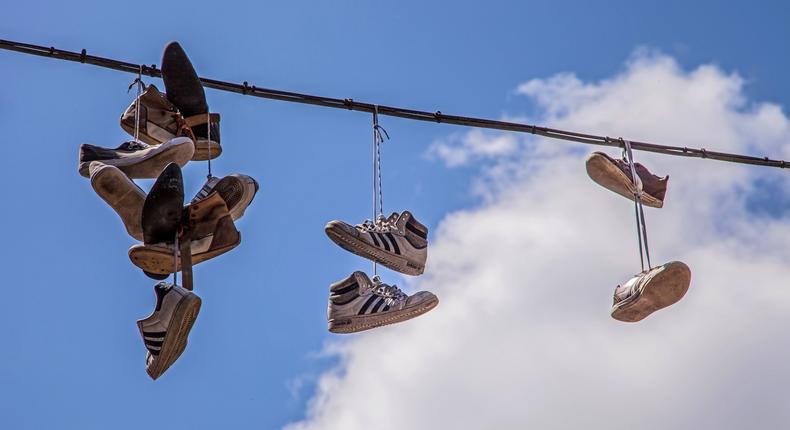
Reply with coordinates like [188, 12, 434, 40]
[143, 294, 202, 380]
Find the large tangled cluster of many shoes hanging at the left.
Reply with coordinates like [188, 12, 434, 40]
[79, 42, 258, 379]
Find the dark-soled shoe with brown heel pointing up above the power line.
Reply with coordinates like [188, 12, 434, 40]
[162, 42, 222, 160]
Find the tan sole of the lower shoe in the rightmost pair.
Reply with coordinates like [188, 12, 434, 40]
[612, 261, 691, 322]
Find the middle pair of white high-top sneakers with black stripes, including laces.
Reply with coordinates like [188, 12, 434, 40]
[324, 108, 439, 333]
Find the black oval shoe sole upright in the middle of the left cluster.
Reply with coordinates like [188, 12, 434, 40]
[141, 163, 184, 243]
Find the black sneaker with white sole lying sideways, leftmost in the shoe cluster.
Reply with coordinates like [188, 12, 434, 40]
[79, 137, 195, 179]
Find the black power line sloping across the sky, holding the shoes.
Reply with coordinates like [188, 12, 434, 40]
[0, 39, 790, 168]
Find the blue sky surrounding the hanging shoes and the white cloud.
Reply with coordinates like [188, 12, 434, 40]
[0, 1, 790, 429]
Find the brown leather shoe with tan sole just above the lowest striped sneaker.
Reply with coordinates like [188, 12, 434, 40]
[129, 215, 241, 276]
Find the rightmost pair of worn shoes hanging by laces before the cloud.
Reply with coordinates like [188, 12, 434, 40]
[586, 145, 691, 322]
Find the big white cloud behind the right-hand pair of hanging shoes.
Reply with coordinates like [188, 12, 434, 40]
[288, 53, 790, 430]
